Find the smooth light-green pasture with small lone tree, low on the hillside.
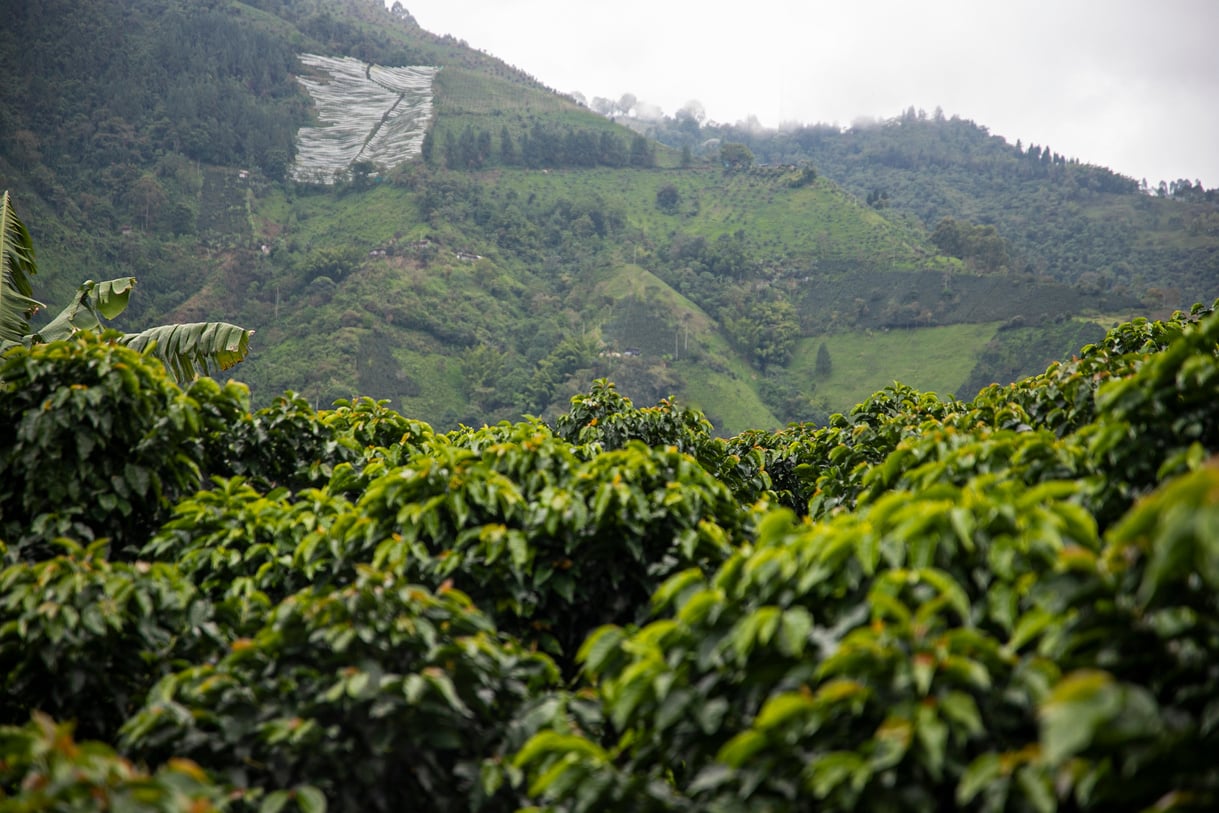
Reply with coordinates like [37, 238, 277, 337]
[787, 322, 1000, 411]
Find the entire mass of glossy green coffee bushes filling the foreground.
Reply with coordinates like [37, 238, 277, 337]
[0, 307, 1219, 813]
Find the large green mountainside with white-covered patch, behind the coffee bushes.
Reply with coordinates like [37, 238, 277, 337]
[0, 0, 1199, 434]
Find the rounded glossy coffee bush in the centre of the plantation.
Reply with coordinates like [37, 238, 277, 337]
[353, 424, 747, 664]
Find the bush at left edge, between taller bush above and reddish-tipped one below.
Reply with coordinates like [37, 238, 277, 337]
[0, 540, 221, 739]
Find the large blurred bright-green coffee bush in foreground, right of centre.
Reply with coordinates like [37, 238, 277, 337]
[518, 479, 1100, 811]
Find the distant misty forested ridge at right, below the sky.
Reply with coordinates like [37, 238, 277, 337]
[638, 107, 1219, 307]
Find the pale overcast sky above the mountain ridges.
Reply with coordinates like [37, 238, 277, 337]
[392, 0, 1219, 189]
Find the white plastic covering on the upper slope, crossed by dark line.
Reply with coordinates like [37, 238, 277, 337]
[291, 54, 440, 184]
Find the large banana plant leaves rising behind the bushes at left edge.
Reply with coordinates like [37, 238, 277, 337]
[0, 191, 254, 384]
